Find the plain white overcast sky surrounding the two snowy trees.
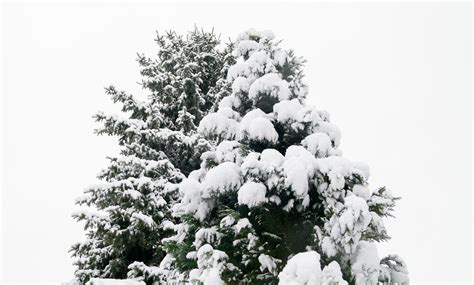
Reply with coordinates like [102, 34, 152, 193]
[0, 2, 473, 282]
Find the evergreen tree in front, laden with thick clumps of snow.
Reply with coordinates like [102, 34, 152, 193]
[166, 30, 407, 284]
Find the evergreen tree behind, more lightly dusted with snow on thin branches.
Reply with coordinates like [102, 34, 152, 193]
[71, 28, 233, 283]
